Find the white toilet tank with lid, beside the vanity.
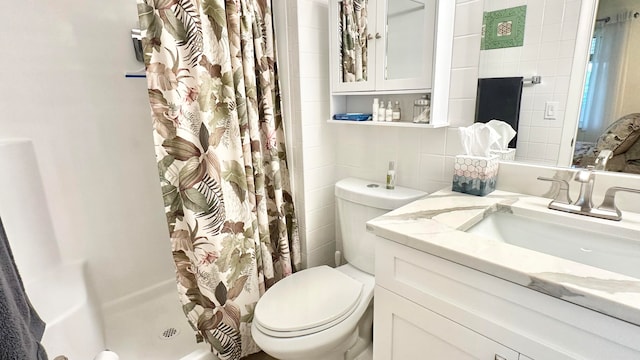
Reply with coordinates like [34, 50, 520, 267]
[335, 178, 427, 274]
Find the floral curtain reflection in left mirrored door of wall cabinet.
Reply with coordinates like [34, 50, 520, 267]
[338, 0, 368, 82]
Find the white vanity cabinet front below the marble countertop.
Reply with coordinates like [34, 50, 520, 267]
[374, 237, 640, 360]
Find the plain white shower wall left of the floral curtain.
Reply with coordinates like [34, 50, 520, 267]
[0, 0, 173, 303]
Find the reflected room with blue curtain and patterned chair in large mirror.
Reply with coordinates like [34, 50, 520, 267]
[573, 0, 640, 174]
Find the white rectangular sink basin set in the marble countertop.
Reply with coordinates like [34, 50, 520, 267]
[467, 212, 640, 278]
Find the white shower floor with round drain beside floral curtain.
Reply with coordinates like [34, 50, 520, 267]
[104, 281, 217, 360]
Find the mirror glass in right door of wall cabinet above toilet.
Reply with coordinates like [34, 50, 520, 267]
[385, 0, 426, 80]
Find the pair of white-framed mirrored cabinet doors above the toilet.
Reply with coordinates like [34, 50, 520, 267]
[330, 0, 436, 93]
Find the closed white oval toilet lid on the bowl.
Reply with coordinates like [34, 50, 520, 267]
[253, 266, 363, 337]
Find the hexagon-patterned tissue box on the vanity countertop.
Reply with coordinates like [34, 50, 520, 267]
[452, 155, 500, 196]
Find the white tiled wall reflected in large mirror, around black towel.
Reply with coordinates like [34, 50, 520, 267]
[480, 0, 580, 165]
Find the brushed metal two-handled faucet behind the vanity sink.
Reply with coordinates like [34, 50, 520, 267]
[538, 160, 640, 221]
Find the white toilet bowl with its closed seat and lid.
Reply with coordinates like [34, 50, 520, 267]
[252, 264, 374, 360]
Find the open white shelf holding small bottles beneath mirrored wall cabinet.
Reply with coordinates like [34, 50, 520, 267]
[327, 93, 449, 129]
